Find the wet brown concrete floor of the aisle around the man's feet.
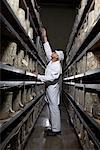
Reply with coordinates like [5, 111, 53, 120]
[25, 101, 81, 150]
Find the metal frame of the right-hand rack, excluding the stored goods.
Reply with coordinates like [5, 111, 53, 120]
[63, 0, 100, 150]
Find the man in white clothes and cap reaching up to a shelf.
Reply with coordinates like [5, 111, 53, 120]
[37, 28, 64, 136]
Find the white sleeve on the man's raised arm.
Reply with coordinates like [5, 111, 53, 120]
[44, 41, 52, 61]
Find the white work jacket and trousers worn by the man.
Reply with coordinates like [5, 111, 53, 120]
[38, 42, 62, 132]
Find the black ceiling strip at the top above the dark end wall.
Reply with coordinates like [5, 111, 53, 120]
[37, 0, 81, 8]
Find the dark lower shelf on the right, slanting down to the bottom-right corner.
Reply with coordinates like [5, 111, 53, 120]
[63, 91, 100, 149]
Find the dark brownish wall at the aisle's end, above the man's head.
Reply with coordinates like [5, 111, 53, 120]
[40, 6, 75, 50]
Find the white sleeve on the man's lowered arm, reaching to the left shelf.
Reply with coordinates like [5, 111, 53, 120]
[37, 69, 60, 82]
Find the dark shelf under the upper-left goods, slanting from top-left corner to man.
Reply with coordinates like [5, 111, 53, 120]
[1, 0, 45, 66]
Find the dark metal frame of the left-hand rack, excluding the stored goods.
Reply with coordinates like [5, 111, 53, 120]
[0, 0, 46, 150]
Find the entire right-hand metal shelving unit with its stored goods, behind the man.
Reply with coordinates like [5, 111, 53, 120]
[63, 0, 100, 150]
